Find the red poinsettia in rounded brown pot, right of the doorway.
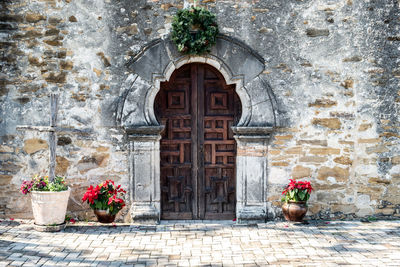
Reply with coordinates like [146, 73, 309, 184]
[282, 179, 314, 222]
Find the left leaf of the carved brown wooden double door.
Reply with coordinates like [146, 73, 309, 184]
[155, 67, 194, 219]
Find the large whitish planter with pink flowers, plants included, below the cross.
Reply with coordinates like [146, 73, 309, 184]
[21, 175, 71, 229]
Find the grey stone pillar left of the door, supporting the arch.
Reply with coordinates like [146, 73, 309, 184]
[126, 126, 164, 223]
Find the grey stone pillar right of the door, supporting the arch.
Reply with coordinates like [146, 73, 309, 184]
[232, 127, 273, 223]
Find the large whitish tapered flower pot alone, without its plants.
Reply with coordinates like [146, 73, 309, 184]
[31, 188, 71, 225]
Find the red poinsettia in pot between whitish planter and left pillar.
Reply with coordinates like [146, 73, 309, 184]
[82, 180, 126, 223]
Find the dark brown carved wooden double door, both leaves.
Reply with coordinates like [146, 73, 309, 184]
[155, 64, 241, 220]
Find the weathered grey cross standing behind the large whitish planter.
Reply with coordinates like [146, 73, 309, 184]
[17, 94, 58, 181]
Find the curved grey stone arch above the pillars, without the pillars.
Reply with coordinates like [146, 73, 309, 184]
[117, 35, 276, 128]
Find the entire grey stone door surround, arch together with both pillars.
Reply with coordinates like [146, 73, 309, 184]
[116, 35, 276, 222]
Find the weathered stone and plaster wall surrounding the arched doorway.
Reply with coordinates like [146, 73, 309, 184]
[0, 0, 400, 221]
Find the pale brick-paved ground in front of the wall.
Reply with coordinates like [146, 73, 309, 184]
[0, 220, 400, 266]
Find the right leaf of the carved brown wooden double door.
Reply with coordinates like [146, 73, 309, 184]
[199, 67, 241, 220]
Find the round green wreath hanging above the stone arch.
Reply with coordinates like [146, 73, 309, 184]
[171, 7, 218, 55]
